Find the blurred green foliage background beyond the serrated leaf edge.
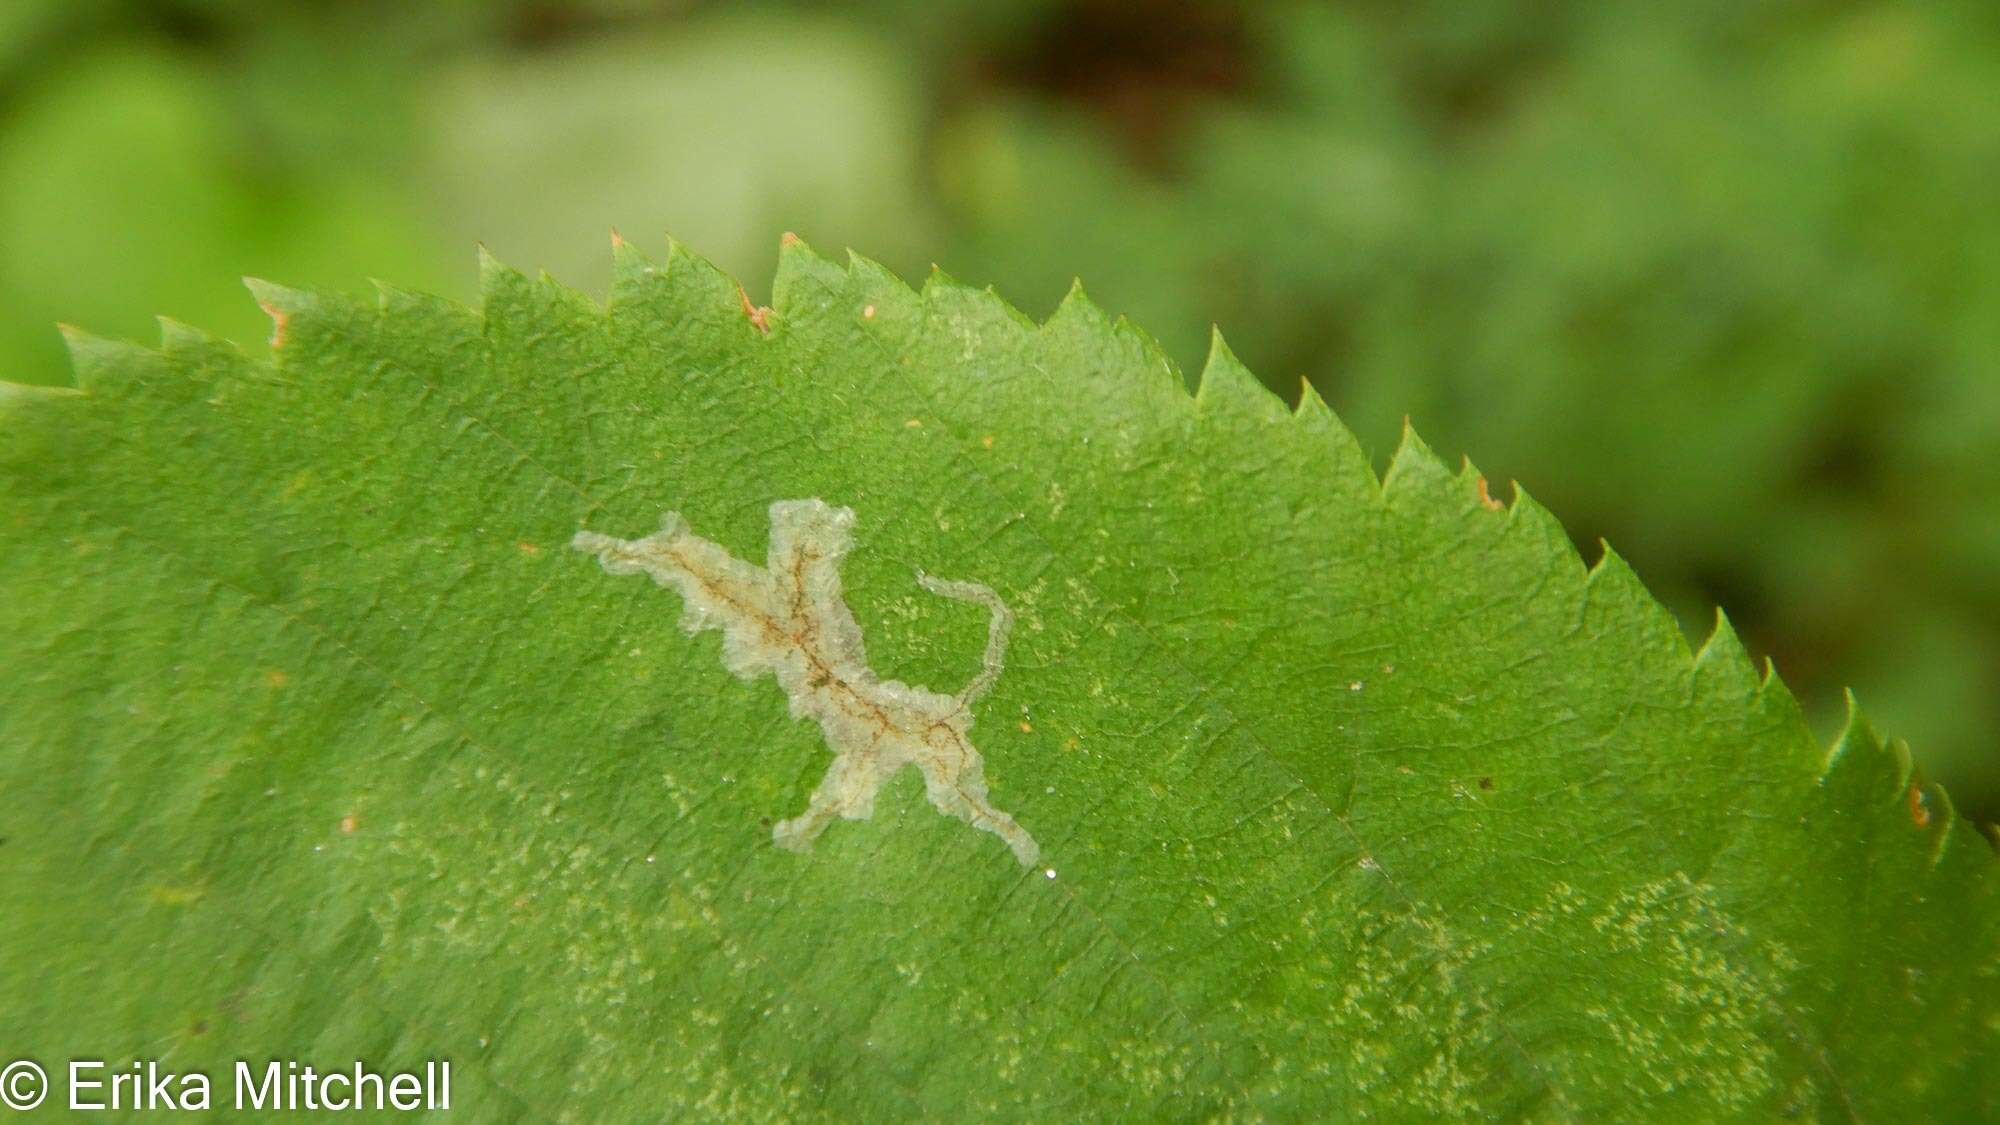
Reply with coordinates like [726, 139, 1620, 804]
[0, 0, 2000, 821]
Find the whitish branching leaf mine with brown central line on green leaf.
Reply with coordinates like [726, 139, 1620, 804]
[570, 498, 1042, 867]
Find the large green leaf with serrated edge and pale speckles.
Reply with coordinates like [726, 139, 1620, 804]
[0, 242, 2000, 1121]
